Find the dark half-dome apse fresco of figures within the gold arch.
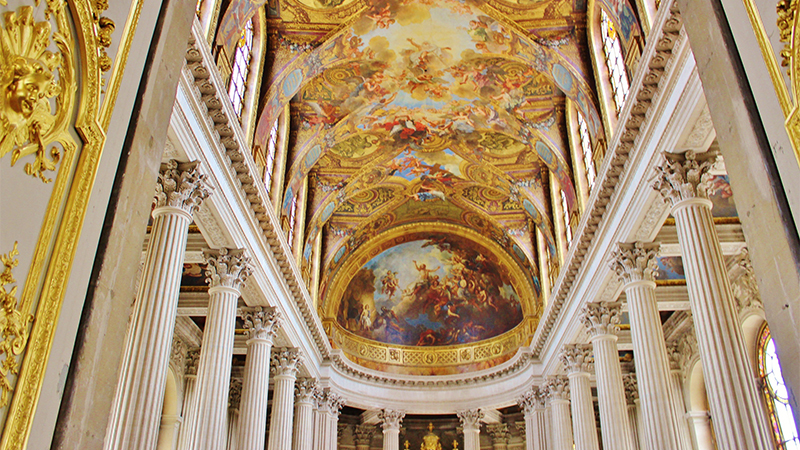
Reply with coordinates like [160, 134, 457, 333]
[337, 233, 523, 346]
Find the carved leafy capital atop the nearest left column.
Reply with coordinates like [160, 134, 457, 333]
[153, 159, 211, 214]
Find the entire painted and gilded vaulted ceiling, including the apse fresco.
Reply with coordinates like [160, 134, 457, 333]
[228, 0, 635, 372]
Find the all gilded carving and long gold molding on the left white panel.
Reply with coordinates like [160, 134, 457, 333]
[0, 0, 126, 444]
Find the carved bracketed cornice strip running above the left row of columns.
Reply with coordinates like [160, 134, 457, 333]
[184, 22, 331, 358]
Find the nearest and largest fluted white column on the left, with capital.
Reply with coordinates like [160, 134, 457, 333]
[105, 160, 209, 450]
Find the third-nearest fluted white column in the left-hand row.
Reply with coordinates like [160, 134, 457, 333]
[238, 306, 281, 450]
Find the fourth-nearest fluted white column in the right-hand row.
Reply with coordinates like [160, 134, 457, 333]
[561, 344, 600, 450]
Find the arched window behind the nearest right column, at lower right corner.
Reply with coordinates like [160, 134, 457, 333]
[758, 324, 800, 450]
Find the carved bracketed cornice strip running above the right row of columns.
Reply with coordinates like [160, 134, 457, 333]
[531, 0, 686, 359]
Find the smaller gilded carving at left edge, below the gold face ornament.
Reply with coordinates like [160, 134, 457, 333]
[0, 242, 33, 407]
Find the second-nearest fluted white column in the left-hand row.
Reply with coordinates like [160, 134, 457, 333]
[194, 248, 252, 450]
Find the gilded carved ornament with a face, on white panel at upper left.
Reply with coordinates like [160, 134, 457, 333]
[0, 4, 75, 183]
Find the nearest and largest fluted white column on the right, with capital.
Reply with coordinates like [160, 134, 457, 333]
[654, 151, 774, 450]
